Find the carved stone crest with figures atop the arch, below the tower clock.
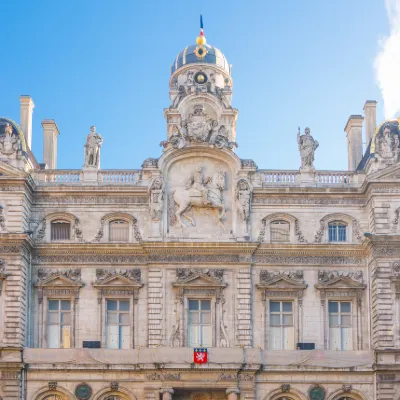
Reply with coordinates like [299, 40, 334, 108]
[161, 104, 237, 149]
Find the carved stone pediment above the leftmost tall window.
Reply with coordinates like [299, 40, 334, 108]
[34, 268, 84, 304]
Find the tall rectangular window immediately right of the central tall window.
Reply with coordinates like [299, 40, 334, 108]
[269, 301, 294, 350]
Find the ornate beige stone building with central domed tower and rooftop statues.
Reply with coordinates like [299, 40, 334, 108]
[0, 26, 400, 400]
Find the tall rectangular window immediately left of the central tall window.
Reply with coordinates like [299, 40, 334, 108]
[106, 300, 130, 349]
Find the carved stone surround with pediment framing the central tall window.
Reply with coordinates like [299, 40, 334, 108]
[171, 268, 229, 347]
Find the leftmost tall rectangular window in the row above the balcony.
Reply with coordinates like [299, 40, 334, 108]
[47, 300, 71, 349]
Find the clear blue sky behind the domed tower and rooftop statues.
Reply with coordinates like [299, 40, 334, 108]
[0, 0, 389, 169]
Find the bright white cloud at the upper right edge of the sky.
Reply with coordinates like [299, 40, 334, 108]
[374, 0, 400, 119]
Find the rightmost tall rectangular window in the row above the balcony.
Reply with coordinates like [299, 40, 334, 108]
[328, 301, 353, 350]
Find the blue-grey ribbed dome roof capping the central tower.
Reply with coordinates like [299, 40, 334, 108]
[171, 44, 230, 75]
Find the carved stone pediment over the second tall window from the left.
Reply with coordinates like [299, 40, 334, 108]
[92, 268, 143, 304]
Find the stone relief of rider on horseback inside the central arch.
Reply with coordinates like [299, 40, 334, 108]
[172, 164, 225, 231]
